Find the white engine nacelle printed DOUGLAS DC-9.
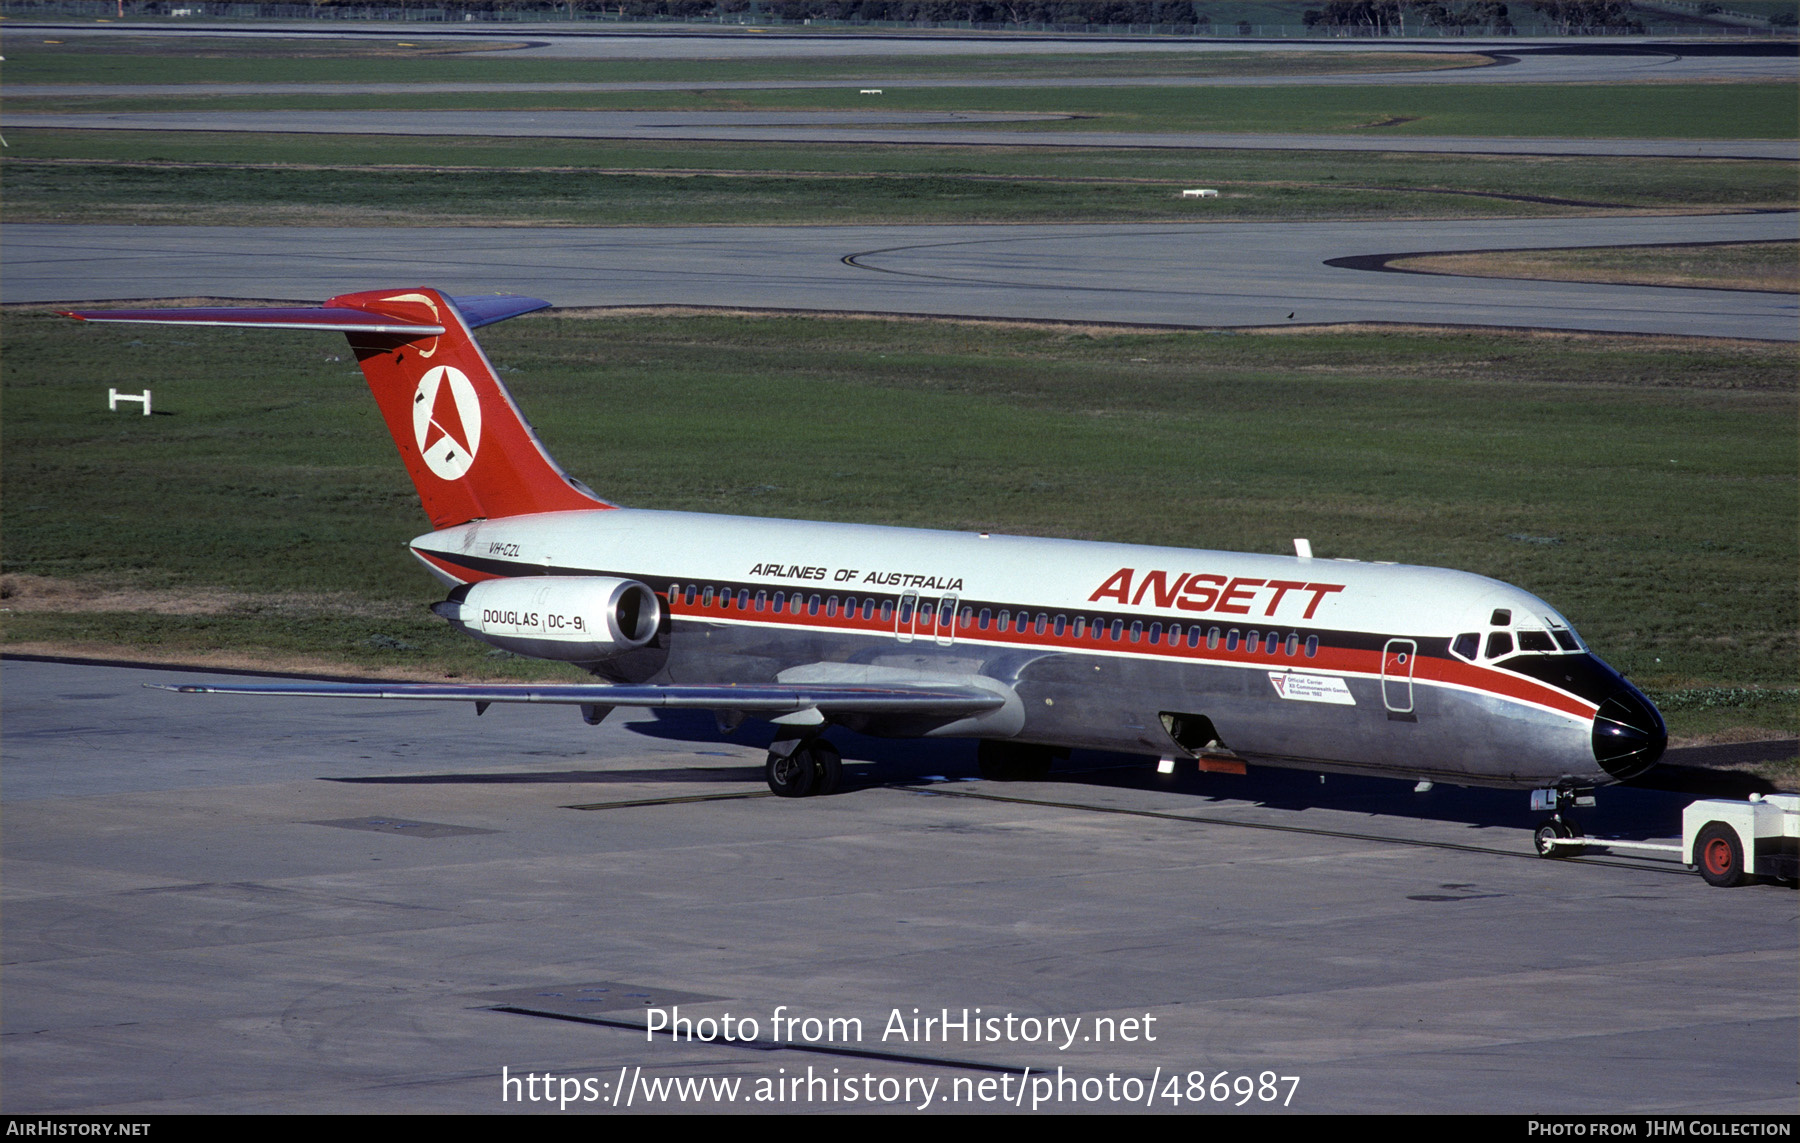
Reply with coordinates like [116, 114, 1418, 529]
[432, 576, 662, 662]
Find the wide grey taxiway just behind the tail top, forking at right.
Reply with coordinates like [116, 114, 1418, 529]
[0, 214, 1800, 340]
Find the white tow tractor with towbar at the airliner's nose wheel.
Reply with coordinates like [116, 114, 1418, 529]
[1535, 794, 1800, 887]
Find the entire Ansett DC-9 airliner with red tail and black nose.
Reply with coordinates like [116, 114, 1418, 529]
[68, 288, 1667, 850]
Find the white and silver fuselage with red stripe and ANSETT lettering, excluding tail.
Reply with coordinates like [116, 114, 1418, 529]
[412, 509, 1660, 787]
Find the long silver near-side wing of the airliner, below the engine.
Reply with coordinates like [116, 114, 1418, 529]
[146, 682, 1006, 715]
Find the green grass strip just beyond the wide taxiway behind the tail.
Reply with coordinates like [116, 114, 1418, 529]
[0, 130, 1796, 225]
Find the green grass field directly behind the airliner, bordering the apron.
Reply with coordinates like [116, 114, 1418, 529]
[0, 311, 1800, 752]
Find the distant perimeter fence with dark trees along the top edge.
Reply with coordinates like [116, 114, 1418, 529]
[0, 0, 1793, 40]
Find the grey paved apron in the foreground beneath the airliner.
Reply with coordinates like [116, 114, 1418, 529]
[0, 661, 1800, 1114]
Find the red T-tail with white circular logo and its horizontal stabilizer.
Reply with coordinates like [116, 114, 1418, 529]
[70, 288, 612, 527]
